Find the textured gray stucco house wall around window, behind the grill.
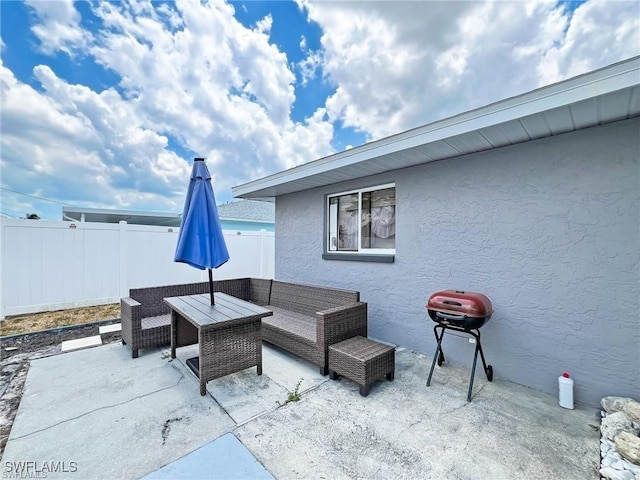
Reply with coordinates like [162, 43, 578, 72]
[276, 118, 640, 405]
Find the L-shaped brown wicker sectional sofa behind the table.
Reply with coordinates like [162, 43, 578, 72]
[121, 278, 367, 375]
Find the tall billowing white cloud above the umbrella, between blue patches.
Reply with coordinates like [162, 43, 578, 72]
[92, 1, 332, 178]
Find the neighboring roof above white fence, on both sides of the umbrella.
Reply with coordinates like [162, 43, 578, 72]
[62, 200, 275, 227]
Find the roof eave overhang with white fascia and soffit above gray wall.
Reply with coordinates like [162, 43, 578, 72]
[232, 56, 640, 198]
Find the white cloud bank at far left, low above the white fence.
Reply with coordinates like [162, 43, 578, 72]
[0, 58, 189, 214]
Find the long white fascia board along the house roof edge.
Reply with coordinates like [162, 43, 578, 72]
[232, 56, 640, 197]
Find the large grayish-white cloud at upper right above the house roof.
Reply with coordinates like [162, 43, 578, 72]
[299, 0, 640, 139]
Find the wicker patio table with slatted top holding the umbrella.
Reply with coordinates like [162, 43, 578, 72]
[164, 292, 273, 395]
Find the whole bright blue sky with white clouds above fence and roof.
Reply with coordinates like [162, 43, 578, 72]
[0, 0, 640, 220]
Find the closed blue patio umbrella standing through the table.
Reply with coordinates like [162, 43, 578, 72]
[174, 158, 229, 305]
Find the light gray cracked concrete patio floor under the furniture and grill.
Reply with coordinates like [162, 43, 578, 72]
[2, 344, 599, 480]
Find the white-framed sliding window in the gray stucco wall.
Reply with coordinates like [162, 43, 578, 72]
[327, 184, 396, 254]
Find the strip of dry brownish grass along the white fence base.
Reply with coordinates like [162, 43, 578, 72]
[0, 303, 120, 337]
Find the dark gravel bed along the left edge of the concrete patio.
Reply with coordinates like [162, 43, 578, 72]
[0, 319, 121, 456]
